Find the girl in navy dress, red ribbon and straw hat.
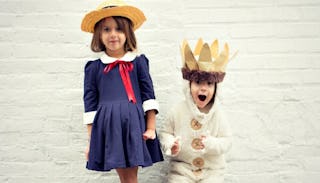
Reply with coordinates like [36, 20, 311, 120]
[81, 0, 163, 183]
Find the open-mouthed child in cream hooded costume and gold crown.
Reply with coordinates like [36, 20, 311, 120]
[159, 39, 232, 183]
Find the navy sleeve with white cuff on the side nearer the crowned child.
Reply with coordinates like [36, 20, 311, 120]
[137, 55, 159, 113]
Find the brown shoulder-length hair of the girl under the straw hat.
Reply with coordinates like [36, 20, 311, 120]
[91, 16, 137, 52]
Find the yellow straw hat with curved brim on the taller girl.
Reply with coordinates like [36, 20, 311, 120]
[81, 0, 146, 33]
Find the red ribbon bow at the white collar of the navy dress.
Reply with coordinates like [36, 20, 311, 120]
[103, 60, 137, 103]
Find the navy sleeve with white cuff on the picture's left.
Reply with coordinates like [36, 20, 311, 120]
[83, 61, 98, 124]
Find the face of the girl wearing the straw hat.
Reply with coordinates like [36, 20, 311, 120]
[100, 17, 126, 58]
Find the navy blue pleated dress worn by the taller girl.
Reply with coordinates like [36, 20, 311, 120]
[83, 55, 163, 171]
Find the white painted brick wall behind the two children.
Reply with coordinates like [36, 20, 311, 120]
[0, 0, 320, 183]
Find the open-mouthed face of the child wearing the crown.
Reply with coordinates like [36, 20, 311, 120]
[190, 81, 215, 109]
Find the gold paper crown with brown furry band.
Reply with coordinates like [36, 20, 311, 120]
[181, 38, 234, 82]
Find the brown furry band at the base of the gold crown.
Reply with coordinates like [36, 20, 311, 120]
[181, 68, 226, 83]
